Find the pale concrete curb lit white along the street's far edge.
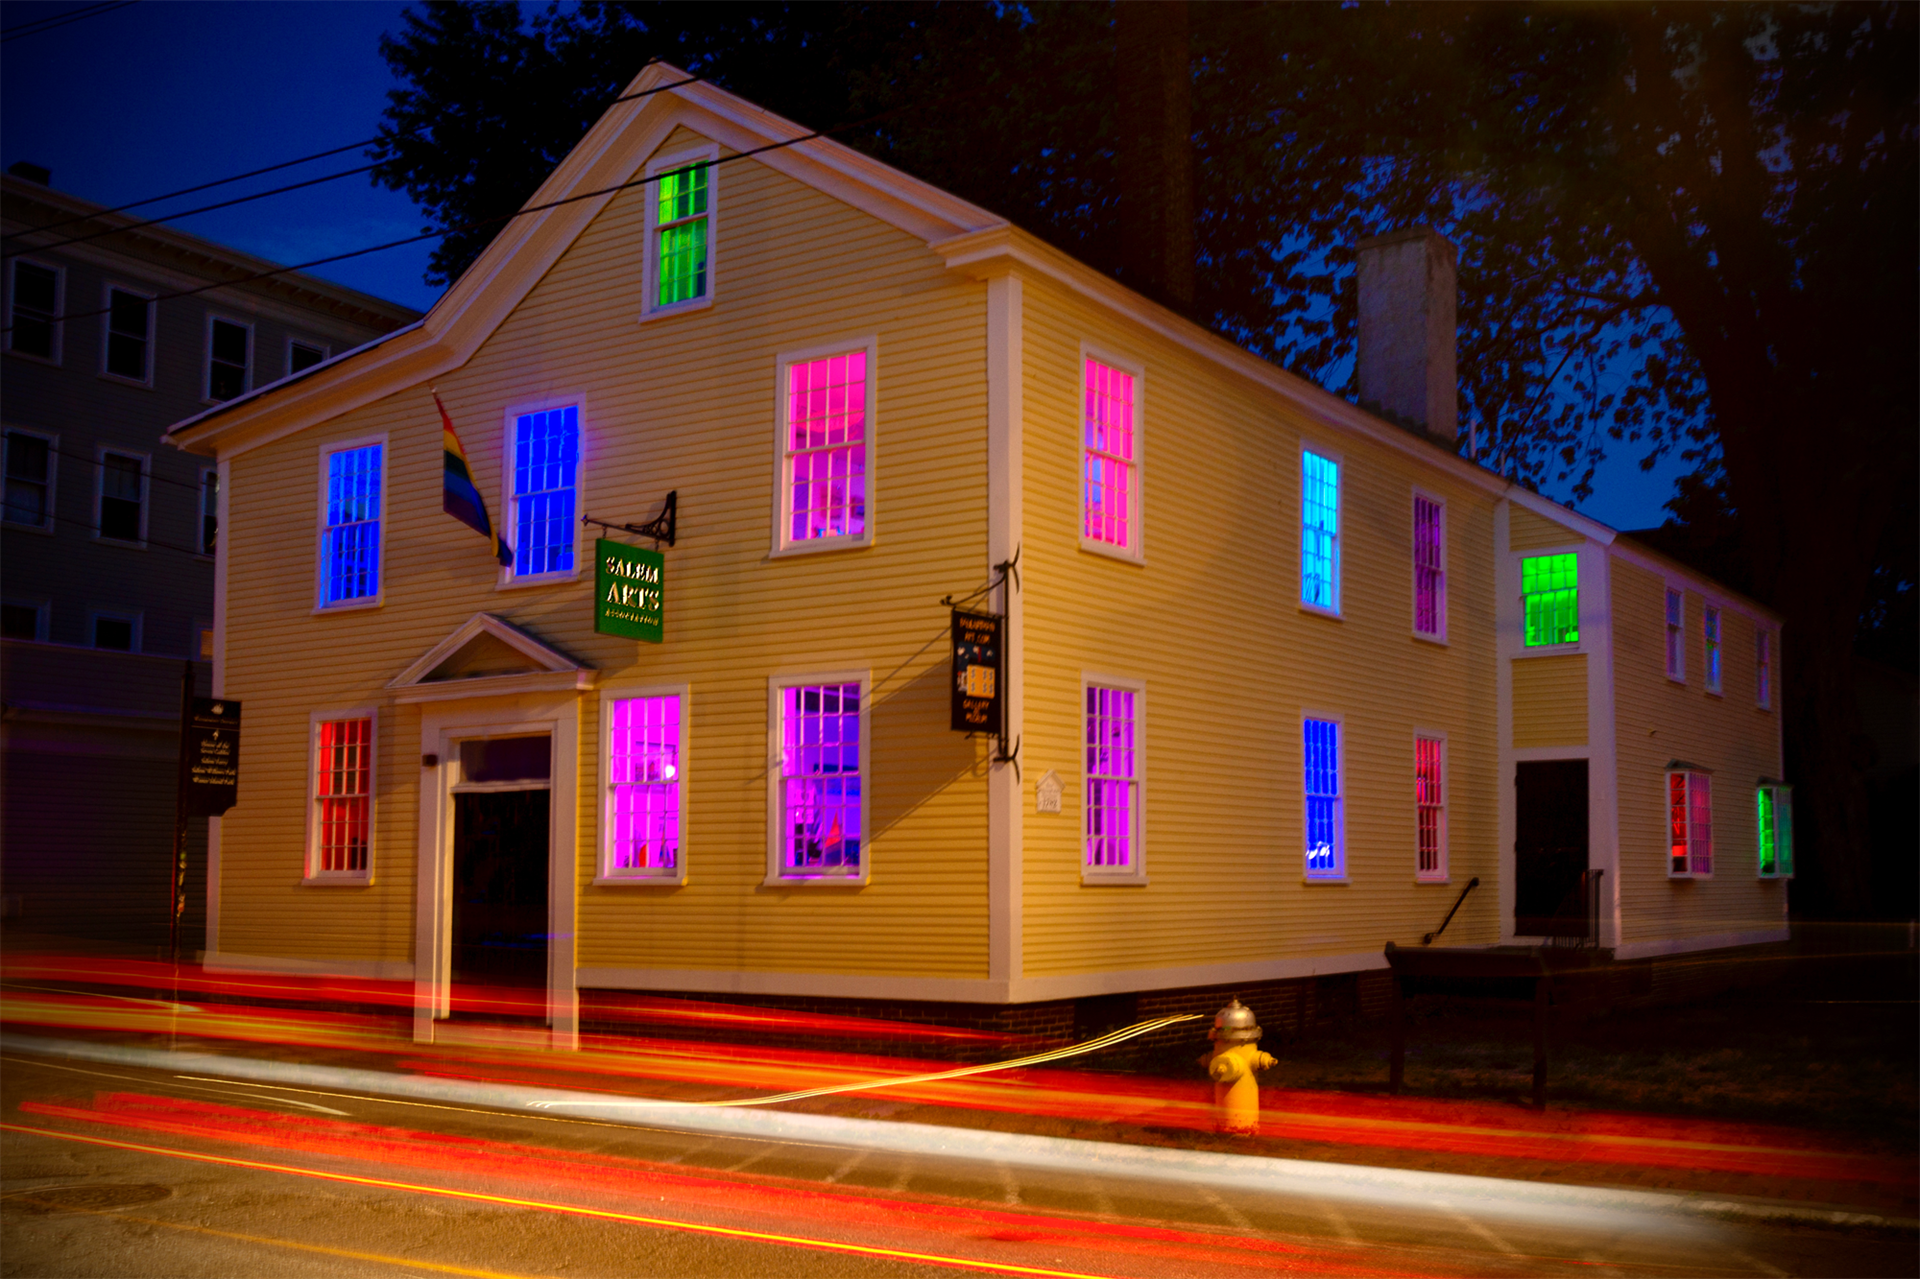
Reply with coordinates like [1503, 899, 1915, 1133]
[0, 1033, 1920, 1233]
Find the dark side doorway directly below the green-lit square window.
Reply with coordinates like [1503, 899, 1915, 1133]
[1513, 759, 1588, 937]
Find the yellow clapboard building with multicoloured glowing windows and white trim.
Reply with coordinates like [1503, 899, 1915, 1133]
[169, 63, 1791, 1045]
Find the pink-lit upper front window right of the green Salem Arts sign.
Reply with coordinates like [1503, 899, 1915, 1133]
[783, 351, 866, 543]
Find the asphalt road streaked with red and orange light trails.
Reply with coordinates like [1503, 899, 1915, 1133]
[0, 1056, 1920, 1279]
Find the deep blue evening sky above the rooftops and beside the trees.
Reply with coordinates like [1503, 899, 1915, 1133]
[0, 0, 1684, 528]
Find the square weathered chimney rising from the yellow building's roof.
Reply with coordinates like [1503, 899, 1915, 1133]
[1354, 227, 1459, 449]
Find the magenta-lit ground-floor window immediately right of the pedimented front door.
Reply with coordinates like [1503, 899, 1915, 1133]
[607, 697, 680, 878]
